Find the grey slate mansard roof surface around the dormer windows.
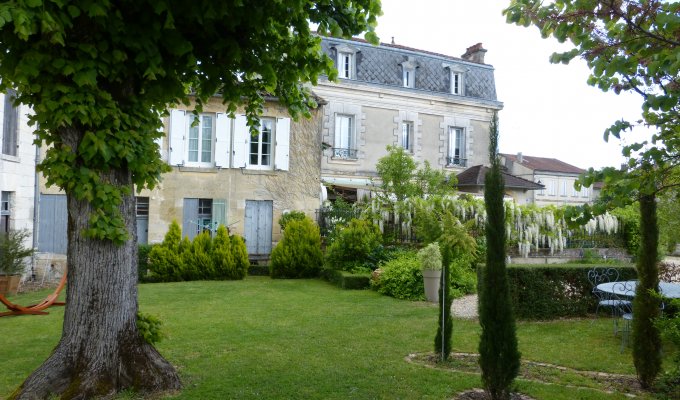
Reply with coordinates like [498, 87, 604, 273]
[321, 37, 497, 102]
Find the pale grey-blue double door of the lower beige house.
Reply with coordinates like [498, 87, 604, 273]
[245, 200, 274, 255]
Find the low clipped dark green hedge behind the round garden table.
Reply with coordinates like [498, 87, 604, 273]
[477, 264, 637, 320]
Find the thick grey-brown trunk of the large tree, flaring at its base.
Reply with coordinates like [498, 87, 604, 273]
[12, 132, 181, 399]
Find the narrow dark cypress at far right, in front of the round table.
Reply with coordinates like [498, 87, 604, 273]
[633, 191, 661, 388]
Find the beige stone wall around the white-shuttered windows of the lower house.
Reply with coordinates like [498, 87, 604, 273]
[138, 98, 321, 247]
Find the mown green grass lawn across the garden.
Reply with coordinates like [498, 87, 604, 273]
[0, 277, 668, 400]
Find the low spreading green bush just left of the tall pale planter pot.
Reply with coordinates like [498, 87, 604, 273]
[371, 252, 425, 300]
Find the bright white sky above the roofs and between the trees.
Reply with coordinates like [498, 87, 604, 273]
[377, 0, 648, 169]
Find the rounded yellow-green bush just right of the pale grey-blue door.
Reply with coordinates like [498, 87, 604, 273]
[271, 217, 323, 278]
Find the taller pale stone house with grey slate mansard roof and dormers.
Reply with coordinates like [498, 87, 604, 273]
[314, 38, 502, 200]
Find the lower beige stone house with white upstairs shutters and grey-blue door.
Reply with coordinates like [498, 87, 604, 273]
[35, 97, 322, 258]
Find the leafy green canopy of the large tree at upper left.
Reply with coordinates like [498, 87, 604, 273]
[0, 0, 381, 243]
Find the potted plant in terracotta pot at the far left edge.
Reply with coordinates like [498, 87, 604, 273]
[0, 230, 34, 295]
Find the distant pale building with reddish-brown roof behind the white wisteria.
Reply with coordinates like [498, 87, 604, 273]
[501, 153, 594, 206]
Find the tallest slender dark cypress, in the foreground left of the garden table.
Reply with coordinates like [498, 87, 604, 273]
[479, 113, 520, 400]
